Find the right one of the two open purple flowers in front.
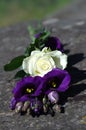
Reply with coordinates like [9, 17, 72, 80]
[38, 68, 71, 95]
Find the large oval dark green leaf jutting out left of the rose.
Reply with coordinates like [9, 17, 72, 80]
[4, 55, 25, 71]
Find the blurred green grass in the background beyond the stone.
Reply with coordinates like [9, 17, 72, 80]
[0, 0, 71, 27]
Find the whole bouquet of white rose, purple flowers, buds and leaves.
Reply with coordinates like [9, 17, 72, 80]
[4, 28, 71, 115]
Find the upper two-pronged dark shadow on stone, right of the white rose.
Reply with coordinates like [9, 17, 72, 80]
[67, 53, 86, 85]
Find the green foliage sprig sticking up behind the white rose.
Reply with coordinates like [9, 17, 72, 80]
[25, 26, 50, 56]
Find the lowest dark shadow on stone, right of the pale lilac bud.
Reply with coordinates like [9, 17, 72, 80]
[59, 84, 86, 105]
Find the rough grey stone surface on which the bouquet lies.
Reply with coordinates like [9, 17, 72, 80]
[0, 0, 86, 130]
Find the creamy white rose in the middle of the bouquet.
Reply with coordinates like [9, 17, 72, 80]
[22, 47, 67, 76]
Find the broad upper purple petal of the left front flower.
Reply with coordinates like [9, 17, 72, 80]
[13, 76, 42, 98]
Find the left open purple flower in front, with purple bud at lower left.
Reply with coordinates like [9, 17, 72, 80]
[10, 76, 42, 109]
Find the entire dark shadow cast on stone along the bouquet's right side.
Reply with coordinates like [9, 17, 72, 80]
[59, 53, 86, 110]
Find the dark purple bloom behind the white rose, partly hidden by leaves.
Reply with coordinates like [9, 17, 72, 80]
[35, 33, 64, 52]
